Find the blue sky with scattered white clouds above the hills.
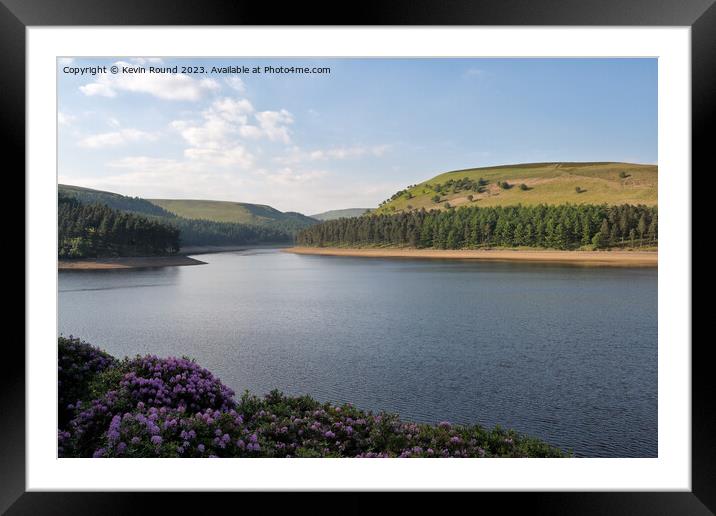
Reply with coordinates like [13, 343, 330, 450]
[57, 57, 657, 214]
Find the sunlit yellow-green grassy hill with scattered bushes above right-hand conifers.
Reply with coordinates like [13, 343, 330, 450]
[376, 162, 658, 213]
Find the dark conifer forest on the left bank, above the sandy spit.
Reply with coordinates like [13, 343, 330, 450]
[57, 195, 179, 258]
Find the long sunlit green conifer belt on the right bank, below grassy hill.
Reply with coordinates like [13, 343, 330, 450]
[296, 204, 658, 249]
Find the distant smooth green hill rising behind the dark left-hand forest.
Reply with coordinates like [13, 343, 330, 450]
[148, 199, 316, 231]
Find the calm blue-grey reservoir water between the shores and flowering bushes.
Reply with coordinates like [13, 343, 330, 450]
[59, 250, 657, 457]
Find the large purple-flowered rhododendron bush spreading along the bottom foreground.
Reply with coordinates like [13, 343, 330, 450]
[58, 340, 564, 457]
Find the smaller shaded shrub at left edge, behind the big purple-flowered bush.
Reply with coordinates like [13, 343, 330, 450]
[57, 335, 117, 428]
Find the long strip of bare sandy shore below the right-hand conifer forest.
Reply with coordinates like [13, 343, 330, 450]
[281, 247, 658, 267]
